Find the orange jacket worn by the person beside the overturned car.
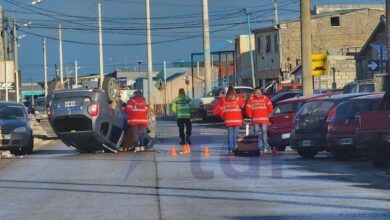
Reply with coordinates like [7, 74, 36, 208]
[125, 97, 149, 126]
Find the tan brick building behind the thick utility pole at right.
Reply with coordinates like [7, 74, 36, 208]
[253, 5, 384, 89]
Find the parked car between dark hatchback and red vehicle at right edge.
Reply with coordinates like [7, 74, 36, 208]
[326, 93, 383, 160]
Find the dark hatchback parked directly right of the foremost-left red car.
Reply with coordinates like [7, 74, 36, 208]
[291, 93, 367, 158]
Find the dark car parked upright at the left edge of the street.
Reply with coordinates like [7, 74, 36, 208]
[0, 102, 34, 154]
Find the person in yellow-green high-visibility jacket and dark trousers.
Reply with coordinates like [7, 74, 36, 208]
[172, 88, 192, 145]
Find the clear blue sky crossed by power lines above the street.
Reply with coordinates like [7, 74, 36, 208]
[0, 0, 384, 82]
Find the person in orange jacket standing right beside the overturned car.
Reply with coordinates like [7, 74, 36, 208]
[122, 91, 149, 152]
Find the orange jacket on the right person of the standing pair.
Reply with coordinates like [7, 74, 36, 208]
[245, 95, 273, 124]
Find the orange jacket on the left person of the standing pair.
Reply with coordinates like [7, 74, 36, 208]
[214, 96, 244, 127]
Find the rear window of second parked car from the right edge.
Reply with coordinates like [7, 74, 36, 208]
[334, 99, 374, 119]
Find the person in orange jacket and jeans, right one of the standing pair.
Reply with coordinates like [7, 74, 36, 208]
[245, 87, 273, 152]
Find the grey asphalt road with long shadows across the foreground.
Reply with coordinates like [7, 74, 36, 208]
[0, 122, 390, 220]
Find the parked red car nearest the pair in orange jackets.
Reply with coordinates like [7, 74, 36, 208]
[268, 93, 333, 151]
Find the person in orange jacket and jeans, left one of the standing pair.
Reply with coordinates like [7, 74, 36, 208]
[215, 86, 244, 153]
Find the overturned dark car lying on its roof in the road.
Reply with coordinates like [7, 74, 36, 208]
[48, 82, 127, 152]
